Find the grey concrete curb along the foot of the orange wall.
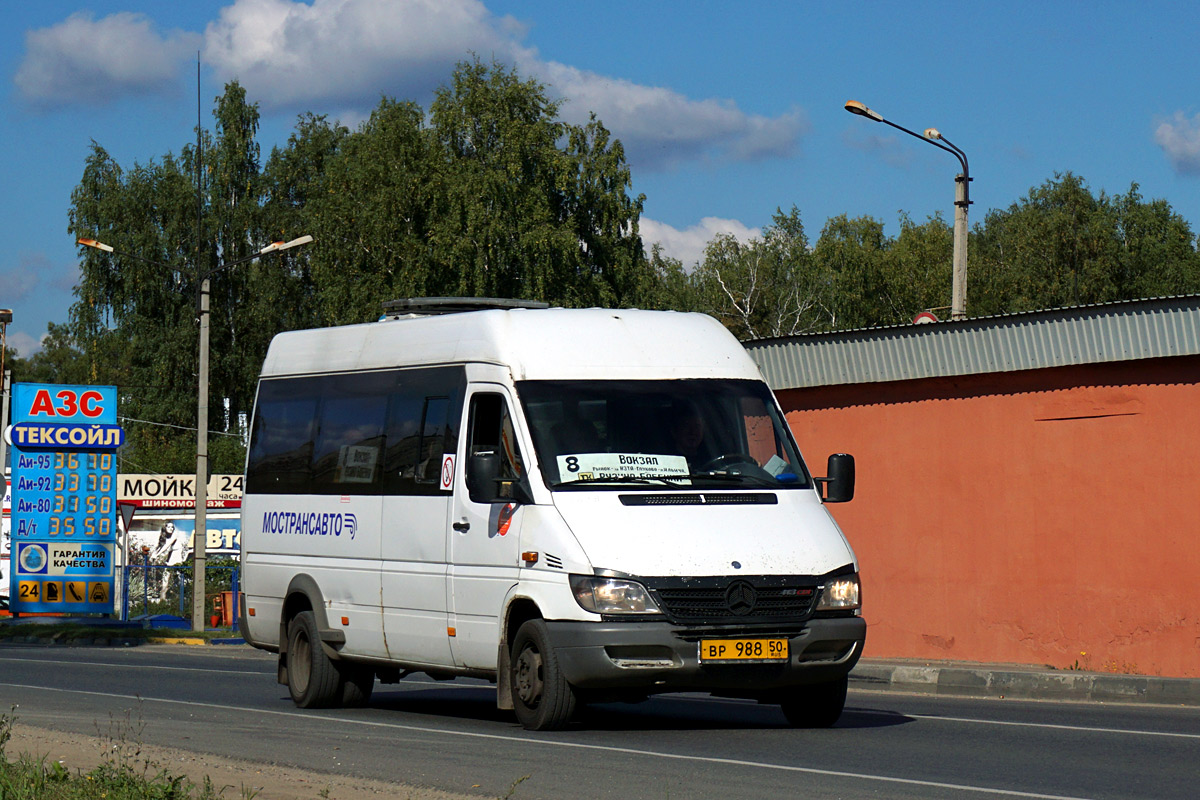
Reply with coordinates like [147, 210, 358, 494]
[850, 661, 1200, 705]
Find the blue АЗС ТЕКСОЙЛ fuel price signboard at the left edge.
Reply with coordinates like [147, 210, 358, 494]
[7, 384, 124, 614]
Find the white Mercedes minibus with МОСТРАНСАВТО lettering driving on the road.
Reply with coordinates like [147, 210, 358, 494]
[240, 297, 866, 730]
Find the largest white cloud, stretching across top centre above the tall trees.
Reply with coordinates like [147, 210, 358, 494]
[204, 0, 808, 169]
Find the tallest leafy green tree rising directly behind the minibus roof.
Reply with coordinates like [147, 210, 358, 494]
[430, 60, 652, 306]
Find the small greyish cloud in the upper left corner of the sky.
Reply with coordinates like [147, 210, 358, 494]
[13, 11, 197, 108]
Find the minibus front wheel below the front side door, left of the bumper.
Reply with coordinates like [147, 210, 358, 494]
[509, 619, 577, 730]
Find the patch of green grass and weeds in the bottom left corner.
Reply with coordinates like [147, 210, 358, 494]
[0, 706, 257, 800]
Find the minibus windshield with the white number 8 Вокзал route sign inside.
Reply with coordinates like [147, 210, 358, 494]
[517, 379, 811, 491]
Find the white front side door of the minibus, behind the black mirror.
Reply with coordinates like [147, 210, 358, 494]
[448, 384, 524, 669]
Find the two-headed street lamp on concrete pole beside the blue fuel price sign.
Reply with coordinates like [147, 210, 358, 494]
[78, 235, 312, 631]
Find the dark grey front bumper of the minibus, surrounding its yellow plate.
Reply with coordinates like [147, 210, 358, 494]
[546, 616, 866, 696]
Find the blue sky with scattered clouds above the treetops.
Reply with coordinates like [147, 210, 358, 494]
[0, 0, 1200, 355]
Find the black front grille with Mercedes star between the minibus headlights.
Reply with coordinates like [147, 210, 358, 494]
[646, 576, 817, 624]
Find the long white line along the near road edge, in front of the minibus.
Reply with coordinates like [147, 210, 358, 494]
[0, 682, 1087, 800]
